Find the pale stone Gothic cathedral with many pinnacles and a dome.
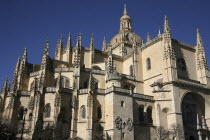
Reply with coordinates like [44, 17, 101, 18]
[0, 4, 210, 140]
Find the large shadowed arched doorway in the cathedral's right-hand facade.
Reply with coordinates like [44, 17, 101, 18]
[182, 93, 205, 140]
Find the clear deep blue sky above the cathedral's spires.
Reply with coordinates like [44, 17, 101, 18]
[0, 0, 210, 86]
